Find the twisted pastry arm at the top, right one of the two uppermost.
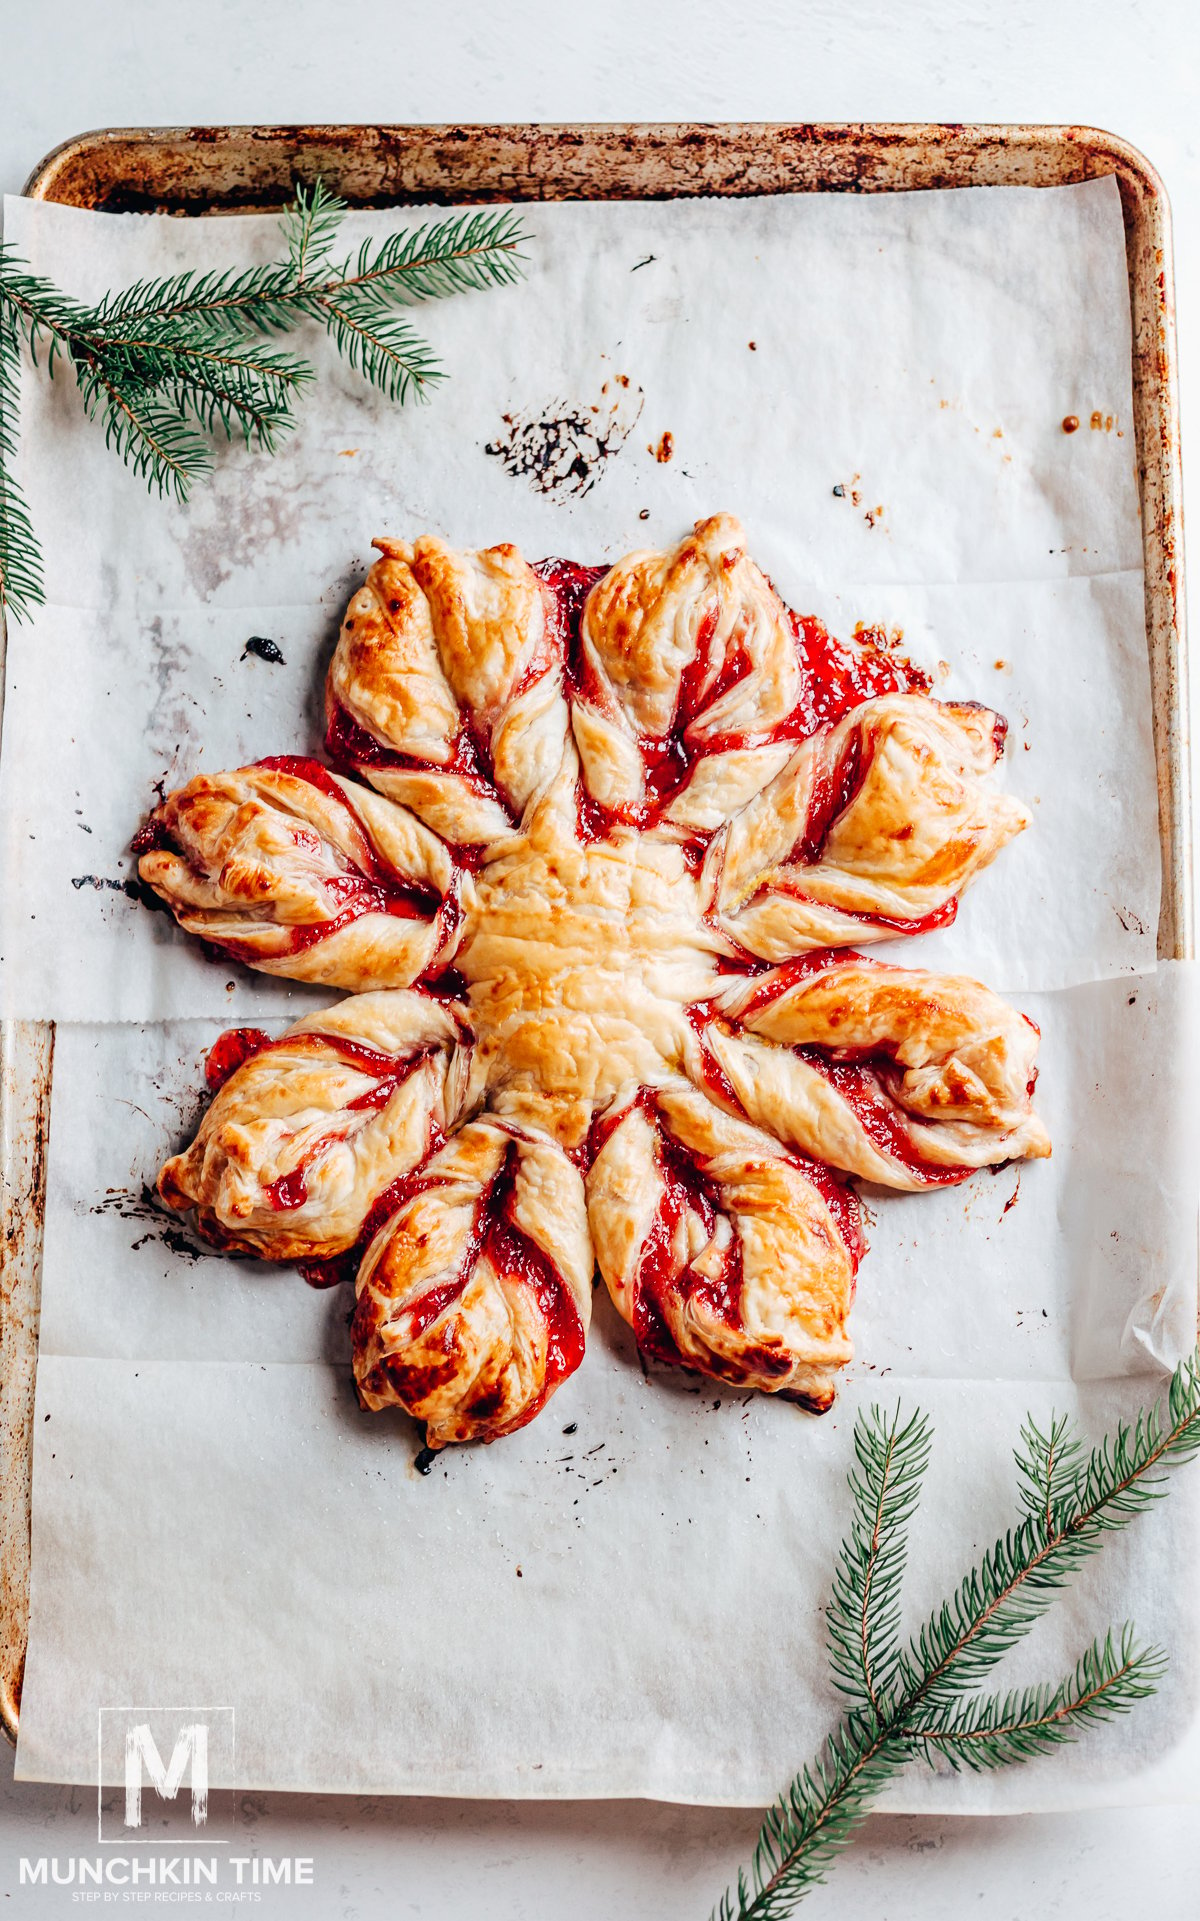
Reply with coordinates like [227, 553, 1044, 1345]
[572, 513, 801, 830]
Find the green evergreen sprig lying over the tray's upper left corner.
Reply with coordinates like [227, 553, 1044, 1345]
[0, 181, 526, 619]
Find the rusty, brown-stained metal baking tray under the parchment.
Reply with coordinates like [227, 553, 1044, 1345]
[0, 123, 1194, 1739]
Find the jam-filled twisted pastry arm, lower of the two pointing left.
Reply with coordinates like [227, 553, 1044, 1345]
[157, 991, 474, 1260]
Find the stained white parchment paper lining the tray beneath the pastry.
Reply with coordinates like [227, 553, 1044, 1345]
[0, 181, 1200, 1812]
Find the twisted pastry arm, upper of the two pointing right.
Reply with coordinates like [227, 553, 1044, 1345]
[707, 693, 1031, 961]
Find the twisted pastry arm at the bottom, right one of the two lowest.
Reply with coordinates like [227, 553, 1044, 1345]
[588, 1082, 864, 1412]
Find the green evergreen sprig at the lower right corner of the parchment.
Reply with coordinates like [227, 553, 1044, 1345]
[714, 1350, 1200, 1921]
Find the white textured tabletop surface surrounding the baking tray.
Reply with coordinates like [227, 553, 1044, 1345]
[0, 0, 1200, 1921]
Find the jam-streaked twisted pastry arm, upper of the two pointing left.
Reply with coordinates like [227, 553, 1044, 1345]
[134, 755, 459, 991]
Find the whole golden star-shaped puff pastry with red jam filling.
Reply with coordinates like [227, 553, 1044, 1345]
[147, 513, 1050, 1448]
